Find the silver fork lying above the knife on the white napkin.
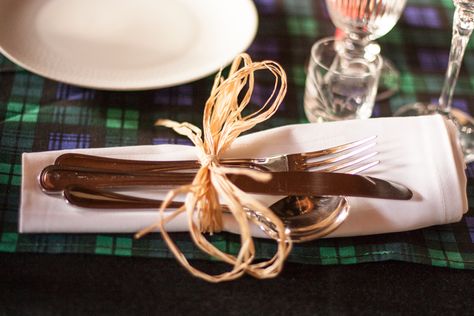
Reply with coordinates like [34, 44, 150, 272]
[54, 136, 379, 173]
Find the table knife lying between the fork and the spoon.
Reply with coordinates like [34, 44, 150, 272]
[39, 165, 413, 200]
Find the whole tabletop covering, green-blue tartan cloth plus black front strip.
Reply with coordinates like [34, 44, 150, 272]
[0, 0, 474, 315]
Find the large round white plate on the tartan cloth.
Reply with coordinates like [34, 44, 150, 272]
[0, 0, 258, 90]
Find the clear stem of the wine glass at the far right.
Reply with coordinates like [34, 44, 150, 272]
[438, 7, 474, 114]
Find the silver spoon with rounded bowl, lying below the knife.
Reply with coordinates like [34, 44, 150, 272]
[63, 186, 349, 242]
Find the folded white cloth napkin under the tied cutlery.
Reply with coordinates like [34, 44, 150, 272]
[19, 115, 468, 237]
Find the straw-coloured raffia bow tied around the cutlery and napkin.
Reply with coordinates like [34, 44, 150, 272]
[136, 54, 291, 282]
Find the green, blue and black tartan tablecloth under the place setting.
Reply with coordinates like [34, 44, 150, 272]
[0, 0, 474, 269]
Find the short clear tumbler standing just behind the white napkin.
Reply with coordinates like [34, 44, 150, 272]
[304, 37, 382, 122]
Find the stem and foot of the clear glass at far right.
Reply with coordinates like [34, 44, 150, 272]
[394, 0, 474, 162]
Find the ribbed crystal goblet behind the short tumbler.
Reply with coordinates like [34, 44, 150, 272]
[326, 0, 406, 99]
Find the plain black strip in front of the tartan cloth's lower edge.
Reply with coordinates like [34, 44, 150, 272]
[0, 254, 474, 315]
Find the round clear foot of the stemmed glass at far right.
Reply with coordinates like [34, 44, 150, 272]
[393, 103, 474, 163]
